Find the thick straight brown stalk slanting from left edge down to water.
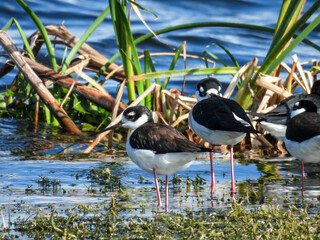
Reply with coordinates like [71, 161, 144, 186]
[0, 32, 81, 134]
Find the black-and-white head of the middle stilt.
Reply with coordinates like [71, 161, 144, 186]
[196, 77, 222, 101]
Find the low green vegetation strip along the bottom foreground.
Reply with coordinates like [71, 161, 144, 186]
[1, 197, 320, 239]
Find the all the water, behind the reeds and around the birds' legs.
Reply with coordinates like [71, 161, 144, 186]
[0, 0, 320, 232]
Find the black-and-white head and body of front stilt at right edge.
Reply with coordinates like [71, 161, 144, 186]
[284, 100, 320, 163]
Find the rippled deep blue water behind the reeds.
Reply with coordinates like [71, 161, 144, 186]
[0, 0, 320, 95]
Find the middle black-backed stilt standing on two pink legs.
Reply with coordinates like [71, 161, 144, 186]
[189, 79, 259, 198]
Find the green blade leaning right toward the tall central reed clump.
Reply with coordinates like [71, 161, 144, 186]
[61, 7, 110, 74]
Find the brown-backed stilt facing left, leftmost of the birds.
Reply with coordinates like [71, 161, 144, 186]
[104, 106, 211, 210]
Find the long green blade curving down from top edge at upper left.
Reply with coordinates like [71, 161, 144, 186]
[16, 0, 57, 71]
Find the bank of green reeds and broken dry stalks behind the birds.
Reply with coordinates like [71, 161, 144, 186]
[0, 0, 320, 148]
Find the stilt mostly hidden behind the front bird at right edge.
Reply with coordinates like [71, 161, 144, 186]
[250, 80, 320, 141]
